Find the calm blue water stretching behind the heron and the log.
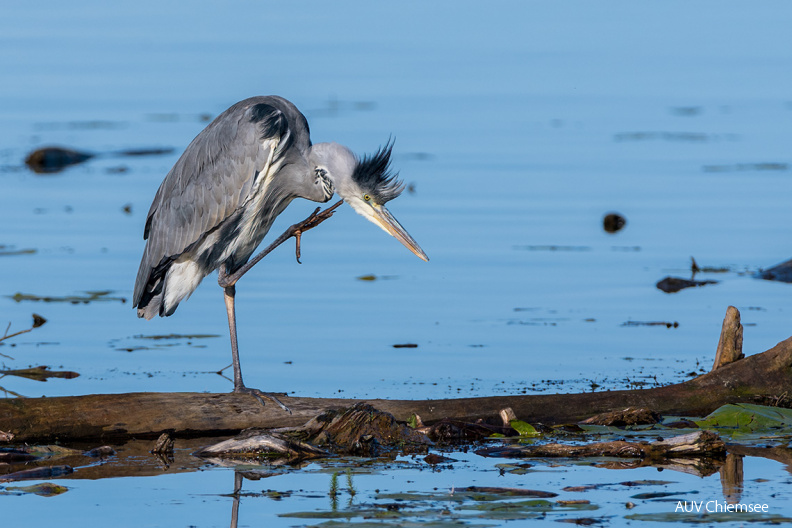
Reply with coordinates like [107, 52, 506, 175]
[0, 1, 792, 525]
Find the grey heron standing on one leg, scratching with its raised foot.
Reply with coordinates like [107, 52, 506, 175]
[133, 96, 428, 408]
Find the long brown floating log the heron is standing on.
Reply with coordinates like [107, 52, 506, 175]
[0, 308, 792, 442]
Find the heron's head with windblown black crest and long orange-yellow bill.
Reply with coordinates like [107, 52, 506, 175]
[310, 143, 429, 261]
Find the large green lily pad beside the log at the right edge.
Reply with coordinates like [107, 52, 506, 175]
[695, 403, 792, 433]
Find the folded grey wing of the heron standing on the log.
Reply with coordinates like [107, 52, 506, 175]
[134, 98, 308, 305]
